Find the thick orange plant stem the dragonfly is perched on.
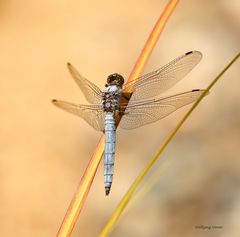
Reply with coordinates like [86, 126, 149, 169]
[57, 0, 179, 237]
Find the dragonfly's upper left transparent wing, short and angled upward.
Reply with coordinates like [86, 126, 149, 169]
[67, 63, 102, 104]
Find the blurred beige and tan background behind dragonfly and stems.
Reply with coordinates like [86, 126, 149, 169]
[0, 0, 240, 237]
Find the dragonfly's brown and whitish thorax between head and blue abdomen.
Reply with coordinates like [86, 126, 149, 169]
[102, 85, 121, 112]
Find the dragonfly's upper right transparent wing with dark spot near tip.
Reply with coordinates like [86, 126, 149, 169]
[124, 51, 202, 100]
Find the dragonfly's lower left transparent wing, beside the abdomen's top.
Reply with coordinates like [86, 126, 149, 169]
[52, 100, 105, 131]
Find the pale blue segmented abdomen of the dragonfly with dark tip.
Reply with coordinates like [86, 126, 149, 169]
[104, 112, 116, 195]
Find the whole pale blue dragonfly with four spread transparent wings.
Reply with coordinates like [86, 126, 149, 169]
[52, 51, 205, 195]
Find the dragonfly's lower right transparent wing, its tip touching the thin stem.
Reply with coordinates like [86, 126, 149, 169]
[119, 90, 204, 129]
